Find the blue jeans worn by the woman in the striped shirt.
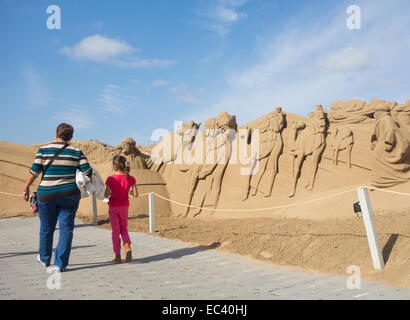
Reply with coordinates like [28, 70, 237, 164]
[38, 195, 81, 269]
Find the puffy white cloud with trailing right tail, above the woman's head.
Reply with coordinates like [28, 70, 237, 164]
[60, 34, 175, 68]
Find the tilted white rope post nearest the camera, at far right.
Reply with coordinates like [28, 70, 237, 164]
[357, 188, 384, 270]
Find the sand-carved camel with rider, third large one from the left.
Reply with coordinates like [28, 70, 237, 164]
[241, 107, 285, 201]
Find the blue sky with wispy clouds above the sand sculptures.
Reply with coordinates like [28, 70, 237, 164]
[0, 0, 410, 145]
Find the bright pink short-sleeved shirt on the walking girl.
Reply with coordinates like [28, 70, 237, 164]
[105, 174, 137, 207]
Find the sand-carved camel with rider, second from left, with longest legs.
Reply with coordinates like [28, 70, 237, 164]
[183, 112, 237, 217]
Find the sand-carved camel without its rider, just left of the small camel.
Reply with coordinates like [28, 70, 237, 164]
[289, 121, 325, 197]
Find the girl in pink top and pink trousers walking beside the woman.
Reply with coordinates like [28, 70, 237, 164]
[105, 155, 138, 263]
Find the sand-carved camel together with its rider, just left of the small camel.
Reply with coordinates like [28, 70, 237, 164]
[289, 105, 327, 197]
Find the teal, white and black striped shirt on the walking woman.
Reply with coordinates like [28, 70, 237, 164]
[30, 142, 92, 201]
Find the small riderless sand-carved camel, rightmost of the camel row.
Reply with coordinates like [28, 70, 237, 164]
[328, 126, 354, 168]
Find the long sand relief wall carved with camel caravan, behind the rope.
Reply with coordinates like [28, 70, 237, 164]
[147, 99, 410, 217]
